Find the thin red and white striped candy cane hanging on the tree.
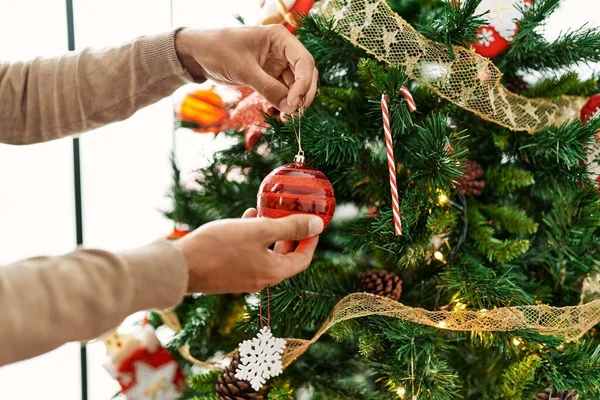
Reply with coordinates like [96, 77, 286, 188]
[381, 86, 417, 236]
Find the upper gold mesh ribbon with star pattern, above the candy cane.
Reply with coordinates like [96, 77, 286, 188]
[315, 0, 587, 133]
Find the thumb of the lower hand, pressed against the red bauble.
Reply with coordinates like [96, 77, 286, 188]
[265, 214, 323, 243]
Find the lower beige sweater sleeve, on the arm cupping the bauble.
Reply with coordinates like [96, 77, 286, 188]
[0, 241, 188, 366]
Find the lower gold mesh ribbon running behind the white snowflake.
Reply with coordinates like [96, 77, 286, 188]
[162, 293, 600, 368]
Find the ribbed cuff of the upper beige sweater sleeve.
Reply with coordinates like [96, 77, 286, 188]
[139, 29, 194, 83]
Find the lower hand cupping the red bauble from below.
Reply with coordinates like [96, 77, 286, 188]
[175, 209, 323, 293]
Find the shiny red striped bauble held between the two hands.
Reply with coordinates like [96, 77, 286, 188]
[257, 163, 335, 227]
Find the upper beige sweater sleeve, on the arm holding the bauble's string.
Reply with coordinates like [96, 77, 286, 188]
[0, 31, 192, 144]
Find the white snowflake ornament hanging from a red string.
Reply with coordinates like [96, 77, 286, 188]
[235, 326, 285, 391]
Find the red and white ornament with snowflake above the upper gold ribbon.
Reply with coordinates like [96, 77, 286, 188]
[468, 0, 531, 58]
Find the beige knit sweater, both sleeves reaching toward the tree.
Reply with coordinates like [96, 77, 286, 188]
[0, 28, 192, 366]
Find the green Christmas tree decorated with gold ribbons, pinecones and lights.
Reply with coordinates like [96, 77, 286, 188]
[151, 0, 600, 400]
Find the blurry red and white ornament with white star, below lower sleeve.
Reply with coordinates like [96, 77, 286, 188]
[101, 326, 185, 400]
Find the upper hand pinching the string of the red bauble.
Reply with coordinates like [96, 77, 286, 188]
[175, 25, 319, 114]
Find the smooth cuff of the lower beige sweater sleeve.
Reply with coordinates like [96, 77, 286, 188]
[120, 240, 188, 311]
